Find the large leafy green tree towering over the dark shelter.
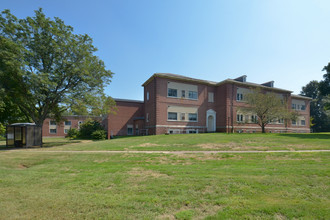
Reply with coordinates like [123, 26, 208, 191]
[0, 9, 112, 126]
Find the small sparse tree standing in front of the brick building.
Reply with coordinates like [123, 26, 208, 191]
[242, 89, 297, 133]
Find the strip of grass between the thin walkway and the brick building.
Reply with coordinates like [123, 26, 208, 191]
[26, 133, 330, 151]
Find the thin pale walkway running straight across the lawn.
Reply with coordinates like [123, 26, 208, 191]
[5, 149, 330, 154]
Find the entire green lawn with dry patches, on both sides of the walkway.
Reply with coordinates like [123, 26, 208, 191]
[0, 134, 330, 219]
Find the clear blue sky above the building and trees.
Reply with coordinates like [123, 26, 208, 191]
[0, 0, 330, 100]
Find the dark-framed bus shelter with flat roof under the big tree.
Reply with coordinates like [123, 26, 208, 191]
[6, 123, 42, 147]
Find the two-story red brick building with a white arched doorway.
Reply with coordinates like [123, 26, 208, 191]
[107, 73, 310, 138]
